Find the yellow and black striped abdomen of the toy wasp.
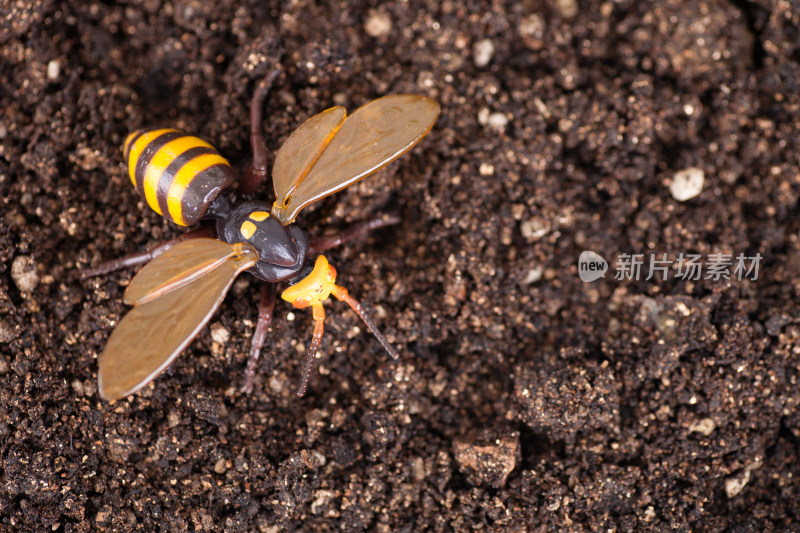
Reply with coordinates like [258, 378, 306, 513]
[122, 129, 235, 226]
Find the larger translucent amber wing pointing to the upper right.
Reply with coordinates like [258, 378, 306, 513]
[272, 95, 439, 225]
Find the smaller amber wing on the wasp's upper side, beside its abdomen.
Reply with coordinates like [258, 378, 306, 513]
[272, 106, 347, 206]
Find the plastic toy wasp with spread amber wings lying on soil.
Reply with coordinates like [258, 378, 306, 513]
[82, 71, 439, 399]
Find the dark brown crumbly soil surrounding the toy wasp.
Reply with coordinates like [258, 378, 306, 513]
[0, 0, 800, 532]
